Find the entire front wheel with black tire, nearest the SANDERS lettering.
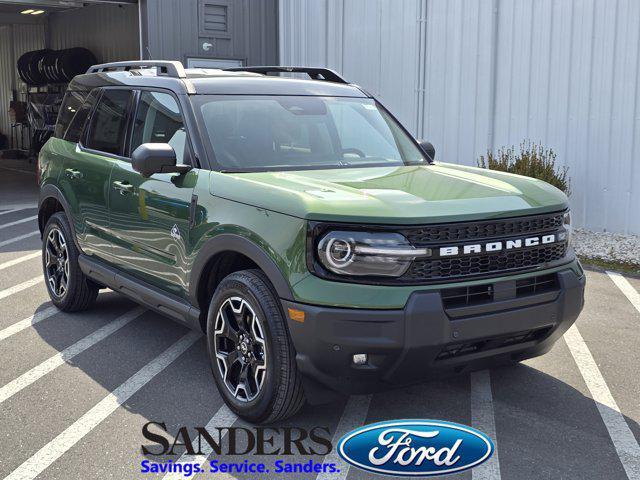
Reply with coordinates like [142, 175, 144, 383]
[207, 270, 304, 423]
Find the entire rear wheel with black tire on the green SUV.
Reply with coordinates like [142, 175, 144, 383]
[42, 212, 98, 312]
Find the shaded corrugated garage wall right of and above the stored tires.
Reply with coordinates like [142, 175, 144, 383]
[49, 5, 140, 62]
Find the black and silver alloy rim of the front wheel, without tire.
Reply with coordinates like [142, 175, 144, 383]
[214, 297, 267, 402]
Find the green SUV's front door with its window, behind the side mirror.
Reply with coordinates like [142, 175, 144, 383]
[109, 90, 198, 297]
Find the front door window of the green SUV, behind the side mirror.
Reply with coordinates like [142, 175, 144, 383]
[131, 92, 187, 163]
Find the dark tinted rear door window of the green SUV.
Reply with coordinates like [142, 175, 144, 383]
[86, 89, 131, 155]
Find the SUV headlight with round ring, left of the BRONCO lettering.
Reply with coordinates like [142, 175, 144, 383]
[317, 231, 431, 277]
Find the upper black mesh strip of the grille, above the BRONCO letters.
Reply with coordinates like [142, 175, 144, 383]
[401, 213, 563, 247]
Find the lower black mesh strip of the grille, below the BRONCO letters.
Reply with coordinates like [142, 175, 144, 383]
[400, 243, 567, 282]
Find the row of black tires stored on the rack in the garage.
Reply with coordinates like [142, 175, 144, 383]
[17, 47, 97, 86]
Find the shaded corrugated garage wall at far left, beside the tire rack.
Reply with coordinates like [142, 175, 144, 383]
[0, 24, 45, 144]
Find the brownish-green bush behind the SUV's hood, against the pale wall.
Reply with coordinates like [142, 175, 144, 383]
[478, 142, 571, 196]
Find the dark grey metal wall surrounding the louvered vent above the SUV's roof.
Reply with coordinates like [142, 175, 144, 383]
[139, 0, 278, 65]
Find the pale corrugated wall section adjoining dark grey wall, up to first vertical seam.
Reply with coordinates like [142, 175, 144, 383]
[279, 0, 419, 131]
